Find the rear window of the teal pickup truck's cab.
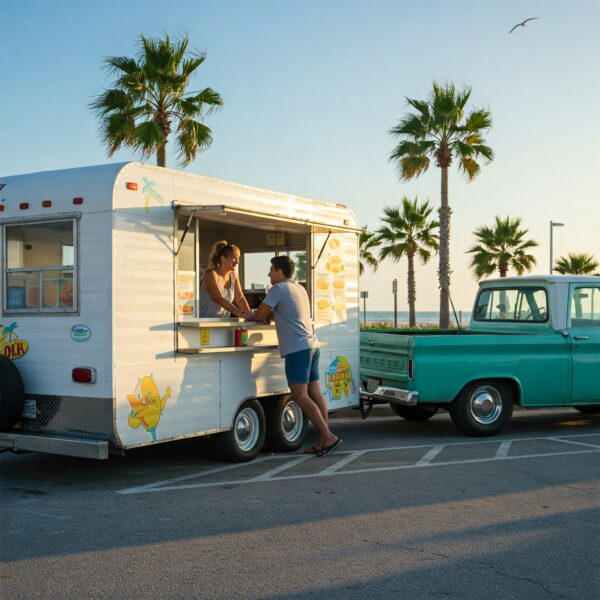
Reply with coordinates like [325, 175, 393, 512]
[474, 287, 548, 323]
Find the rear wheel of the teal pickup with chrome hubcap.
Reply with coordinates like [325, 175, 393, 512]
[448, 380, 513, 436]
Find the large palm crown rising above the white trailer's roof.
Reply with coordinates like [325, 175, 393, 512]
[90, 35, 223, 167]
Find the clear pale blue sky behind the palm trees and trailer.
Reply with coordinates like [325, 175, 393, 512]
[0, 0, 600, 310]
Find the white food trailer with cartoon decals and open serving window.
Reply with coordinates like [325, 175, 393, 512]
[0, 163, 359, 460]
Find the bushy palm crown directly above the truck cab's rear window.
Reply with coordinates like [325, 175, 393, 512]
[467, 217, 538, 280]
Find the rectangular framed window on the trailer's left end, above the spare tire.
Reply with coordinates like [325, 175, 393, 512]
[2, 218, 78, 314]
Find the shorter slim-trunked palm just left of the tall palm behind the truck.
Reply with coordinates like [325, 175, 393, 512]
[377, 198, 440, 327]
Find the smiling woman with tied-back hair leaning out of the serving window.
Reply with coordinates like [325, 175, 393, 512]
[200, 240, 252, 318]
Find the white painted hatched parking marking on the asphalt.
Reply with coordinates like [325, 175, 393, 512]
[117, 433, 600, 494]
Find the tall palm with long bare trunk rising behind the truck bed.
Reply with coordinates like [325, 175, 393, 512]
[390, 81, 494, 328]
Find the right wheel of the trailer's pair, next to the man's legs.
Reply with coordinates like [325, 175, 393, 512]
[265, 396, 308, 452]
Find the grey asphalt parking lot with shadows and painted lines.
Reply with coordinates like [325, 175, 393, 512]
[0, 407, 600, 600]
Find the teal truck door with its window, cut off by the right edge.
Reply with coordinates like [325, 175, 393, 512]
[568, 284, 600, 404]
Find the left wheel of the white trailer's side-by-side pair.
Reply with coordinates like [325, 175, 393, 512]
[219, 399, 266, 462]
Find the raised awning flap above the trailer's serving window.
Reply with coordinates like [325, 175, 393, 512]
[174, 202, 361, 233]
